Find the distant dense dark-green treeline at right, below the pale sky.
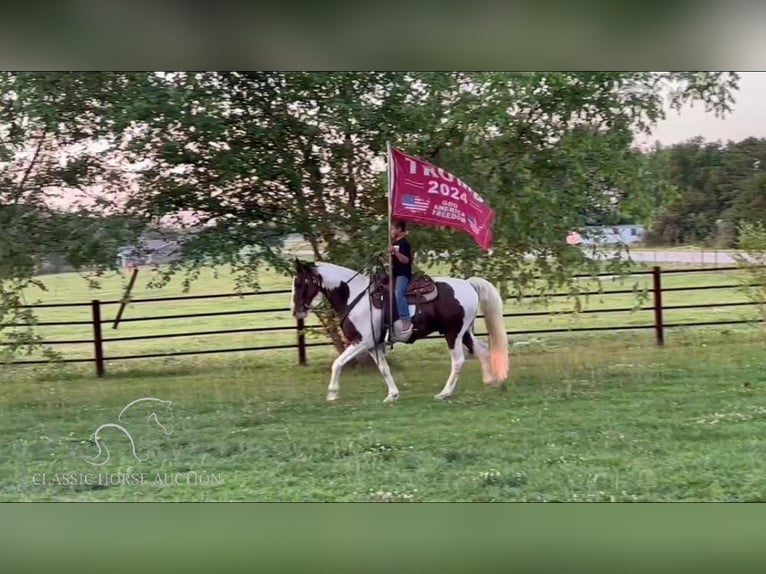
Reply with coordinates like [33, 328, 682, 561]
[647, 138, 766, 248]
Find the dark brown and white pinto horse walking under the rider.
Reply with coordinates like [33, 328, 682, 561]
[290, 259, 508, 403]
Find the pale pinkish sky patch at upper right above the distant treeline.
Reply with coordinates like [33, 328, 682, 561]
[638, 72, 766, 145]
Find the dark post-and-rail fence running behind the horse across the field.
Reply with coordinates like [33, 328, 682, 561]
[0, 266, 759, 377]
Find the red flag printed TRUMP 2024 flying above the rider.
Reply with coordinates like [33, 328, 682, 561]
[388, 148, 495, 251]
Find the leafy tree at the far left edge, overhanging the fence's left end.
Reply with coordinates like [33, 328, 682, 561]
[0, 73, 150, 358]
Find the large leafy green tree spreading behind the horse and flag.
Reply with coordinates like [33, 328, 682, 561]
[3, 72, 737, 360]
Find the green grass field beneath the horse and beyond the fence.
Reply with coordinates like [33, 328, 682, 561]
[0, 264, 766, 501]
